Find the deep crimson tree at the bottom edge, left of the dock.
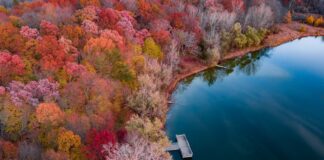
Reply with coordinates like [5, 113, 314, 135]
[85, 130, 116, 160]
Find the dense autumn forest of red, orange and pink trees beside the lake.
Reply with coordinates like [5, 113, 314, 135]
[0, 0, 324, 160]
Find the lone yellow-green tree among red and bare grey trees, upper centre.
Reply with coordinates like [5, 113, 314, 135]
[143, 37, 163, 60]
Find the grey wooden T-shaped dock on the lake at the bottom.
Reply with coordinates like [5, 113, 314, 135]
[166, 134, 193, 158]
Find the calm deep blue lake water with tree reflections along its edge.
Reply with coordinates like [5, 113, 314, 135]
[166, 37, 324, 160]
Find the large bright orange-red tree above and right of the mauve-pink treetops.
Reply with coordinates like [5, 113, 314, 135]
[36, 36, 73, 71]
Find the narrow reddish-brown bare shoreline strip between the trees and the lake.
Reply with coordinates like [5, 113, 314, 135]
[164, 22, 324, 104]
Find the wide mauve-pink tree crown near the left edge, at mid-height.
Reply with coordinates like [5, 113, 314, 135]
[7, 79, 59, 106]
